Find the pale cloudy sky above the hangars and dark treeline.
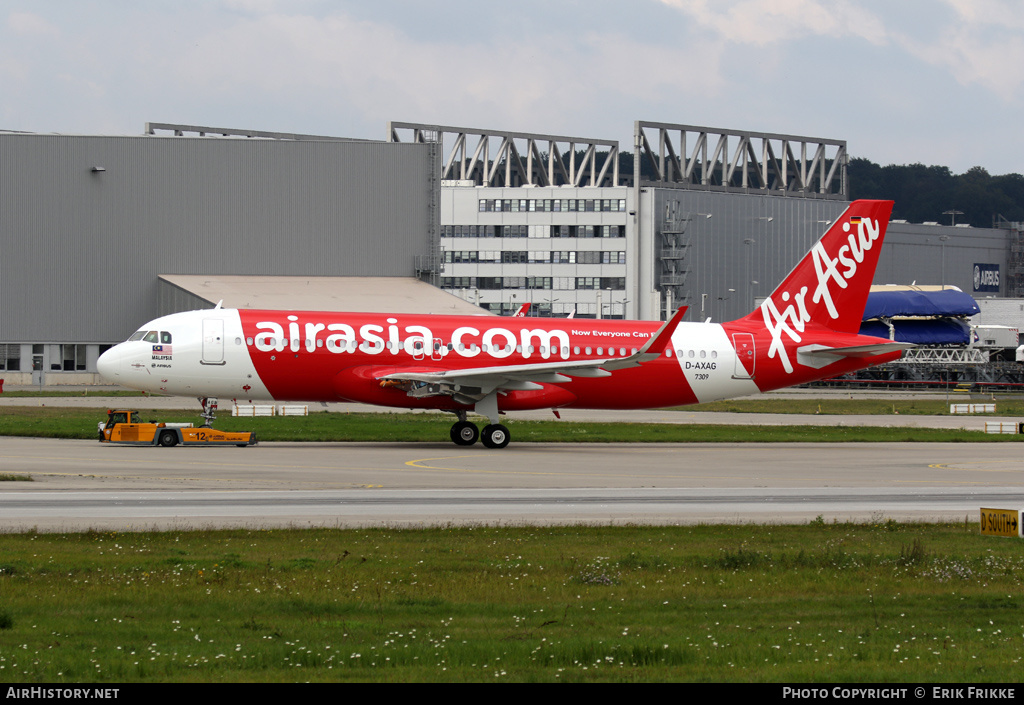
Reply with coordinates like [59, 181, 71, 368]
[0, 0, 1024, 174]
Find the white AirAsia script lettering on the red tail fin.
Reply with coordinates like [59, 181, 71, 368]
[761, 216, 882, 373]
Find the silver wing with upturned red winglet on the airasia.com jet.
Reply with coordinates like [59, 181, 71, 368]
[378, 306, 686, 404]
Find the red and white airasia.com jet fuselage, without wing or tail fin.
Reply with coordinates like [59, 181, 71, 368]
[98, 308, 899, 411]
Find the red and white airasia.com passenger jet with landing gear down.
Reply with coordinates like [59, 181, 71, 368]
[98, 201, 908, 448]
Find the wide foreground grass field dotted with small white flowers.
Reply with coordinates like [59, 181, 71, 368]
[0, 521, 1024, 683]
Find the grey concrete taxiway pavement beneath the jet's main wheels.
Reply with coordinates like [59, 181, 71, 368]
[0, 438, 1024, 531]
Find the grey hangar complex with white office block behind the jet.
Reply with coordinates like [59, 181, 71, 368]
[0, 121, 1024, 386]
